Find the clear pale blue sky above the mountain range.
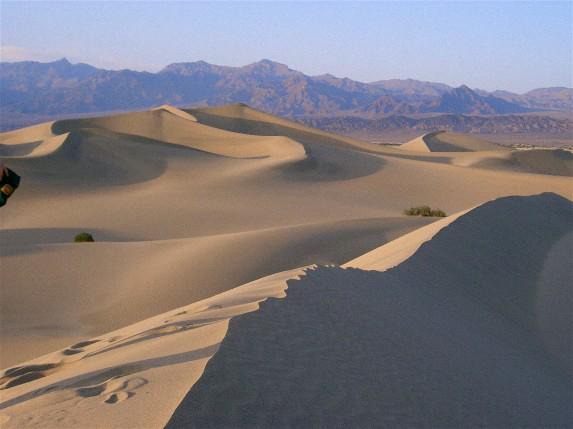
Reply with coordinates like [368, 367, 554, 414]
[0, 0, 573, 93]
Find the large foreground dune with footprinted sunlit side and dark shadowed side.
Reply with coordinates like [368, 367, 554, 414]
[0, 194, 573, 427]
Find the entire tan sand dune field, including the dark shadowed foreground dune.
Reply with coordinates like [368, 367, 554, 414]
[0, 104, 573, 429]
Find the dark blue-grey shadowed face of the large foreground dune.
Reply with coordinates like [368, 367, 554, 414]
[167, 194, 573, 428]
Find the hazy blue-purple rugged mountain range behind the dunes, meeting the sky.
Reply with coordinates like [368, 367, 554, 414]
[0, 59, 573, 129]
